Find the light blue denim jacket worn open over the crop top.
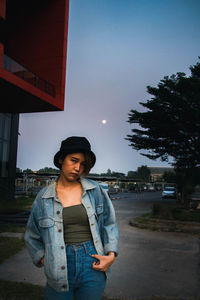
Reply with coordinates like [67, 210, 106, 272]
[25, 178, 118, 291]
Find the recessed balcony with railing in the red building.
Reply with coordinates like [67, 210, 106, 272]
[3, 54, 56, 98]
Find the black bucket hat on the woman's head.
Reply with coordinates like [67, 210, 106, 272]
[54, 136, 96, 169]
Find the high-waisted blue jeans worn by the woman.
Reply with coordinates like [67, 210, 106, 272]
[44, 241, 106, 300]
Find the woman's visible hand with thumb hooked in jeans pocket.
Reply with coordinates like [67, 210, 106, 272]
[92, 252, 115, 272]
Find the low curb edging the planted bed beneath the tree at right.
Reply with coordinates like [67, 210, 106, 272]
[129, 219, 200, 234]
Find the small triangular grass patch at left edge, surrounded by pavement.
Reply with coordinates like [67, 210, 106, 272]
[0, 237, 25, 264]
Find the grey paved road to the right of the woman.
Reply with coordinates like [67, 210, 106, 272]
[105, 192, 200, 299]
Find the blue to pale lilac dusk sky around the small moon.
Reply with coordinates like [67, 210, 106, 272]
[17, 0, 200, 173]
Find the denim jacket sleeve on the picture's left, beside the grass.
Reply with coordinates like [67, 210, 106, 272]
[24, 197, 44, 267]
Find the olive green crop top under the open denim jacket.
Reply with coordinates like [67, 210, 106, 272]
[63, 204, 92, 245]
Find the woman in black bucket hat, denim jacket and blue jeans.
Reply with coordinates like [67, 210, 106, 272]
[25, 136, 118, 300]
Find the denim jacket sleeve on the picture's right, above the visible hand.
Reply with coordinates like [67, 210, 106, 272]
[101, 188, 118, 256]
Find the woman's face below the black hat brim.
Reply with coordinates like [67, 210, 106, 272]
[59, 153, 85, 182]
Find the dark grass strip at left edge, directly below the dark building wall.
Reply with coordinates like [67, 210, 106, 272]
[0, 196, 35, 214]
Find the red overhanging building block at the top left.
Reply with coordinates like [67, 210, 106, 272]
[0, 0, 69, 113]
